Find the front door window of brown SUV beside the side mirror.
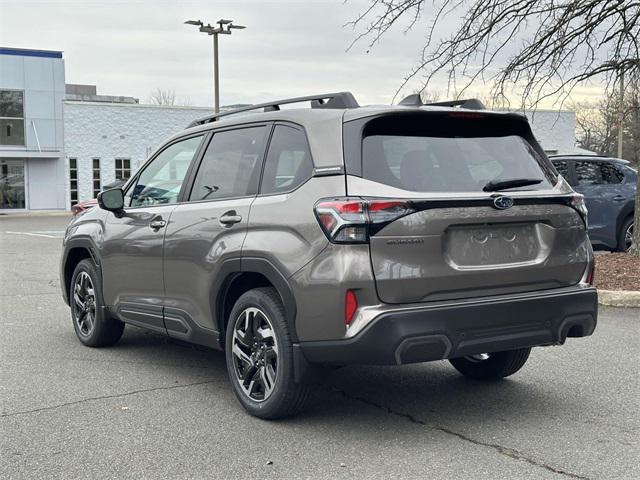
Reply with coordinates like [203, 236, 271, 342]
[125, 135, 202, 207]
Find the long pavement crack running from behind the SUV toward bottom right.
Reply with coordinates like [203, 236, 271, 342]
[332, 387, 590, 480]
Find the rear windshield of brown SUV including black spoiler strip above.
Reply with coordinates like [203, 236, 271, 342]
[362, 114, 556, 193]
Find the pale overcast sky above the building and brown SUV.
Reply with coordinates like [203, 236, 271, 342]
[0, 0, 597, 106]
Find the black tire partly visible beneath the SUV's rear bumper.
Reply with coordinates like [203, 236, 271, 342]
[449, 348, 531, 380]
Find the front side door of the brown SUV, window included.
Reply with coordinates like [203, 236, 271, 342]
[102, 135, 203, 332]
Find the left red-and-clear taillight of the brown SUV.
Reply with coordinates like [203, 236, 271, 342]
[315, 198, 415, 243]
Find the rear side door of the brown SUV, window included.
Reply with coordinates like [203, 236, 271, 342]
[164, 124, 270, 346]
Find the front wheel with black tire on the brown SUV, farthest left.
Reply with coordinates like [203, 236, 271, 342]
[69, 259, 124, 347]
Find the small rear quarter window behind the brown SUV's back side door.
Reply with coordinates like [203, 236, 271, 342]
[260, 125, 313, 194]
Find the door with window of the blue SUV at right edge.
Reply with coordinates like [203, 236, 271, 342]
[574, 160, 627, 248]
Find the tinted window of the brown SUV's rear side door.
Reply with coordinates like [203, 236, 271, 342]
[189, 127, 267, 201]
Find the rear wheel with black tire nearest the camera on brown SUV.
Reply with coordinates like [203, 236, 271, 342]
[225, 288, 309, 420]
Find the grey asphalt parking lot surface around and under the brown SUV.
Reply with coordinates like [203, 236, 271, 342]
[0, 216, 640, 479]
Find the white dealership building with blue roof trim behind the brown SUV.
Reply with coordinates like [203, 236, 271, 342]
[0, 48, 580, 213]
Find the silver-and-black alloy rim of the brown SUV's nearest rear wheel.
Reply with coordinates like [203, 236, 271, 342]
[231, 307, 278, 402]
